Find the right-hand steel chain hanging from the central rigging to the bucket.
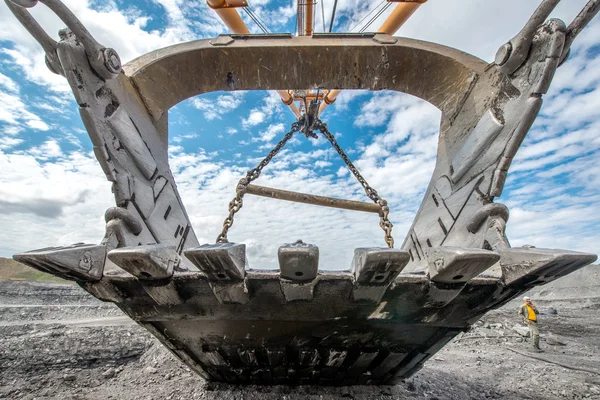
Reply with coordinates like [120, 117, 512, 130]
[313, 120, 394, 248]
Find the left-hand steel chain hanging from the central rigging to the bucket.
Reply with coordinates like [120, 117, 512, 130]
[217, 121, 300, 243]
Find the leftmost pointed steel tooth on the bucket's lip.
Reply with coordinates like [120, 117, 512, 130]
[13, 243, 106, 281]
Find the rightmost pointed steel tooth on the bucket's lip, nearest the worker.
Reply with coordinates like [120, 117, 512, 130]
[498, 247, 598, 288]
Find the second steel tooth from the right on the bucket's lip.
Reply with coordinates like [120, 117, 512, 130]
[425, 247, 500, 284]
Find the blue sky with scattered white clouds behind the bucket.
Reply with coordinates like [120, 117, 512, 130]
[0, 0, 600, 269]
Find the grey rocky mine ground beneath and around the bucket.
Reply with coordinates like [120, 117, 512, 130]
[0, 280, 600, 400]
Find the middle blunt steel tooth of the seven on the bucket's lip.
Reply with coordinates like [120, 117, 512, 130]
[277, 240, 319, 282]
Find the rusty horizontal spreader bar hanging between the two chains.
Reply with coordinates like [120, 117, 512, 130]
[246, 185, 381, 214]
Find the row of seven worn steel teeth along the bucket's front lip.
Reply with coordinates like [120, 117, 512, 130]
[14, 241, 596, 307]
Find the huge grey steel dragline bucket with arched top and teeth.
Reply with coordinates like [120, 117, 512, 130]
[6, 0, 599, 385]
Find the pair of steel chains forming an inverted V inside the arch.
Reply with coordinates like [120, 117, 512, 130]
[217, 118, 394, 248]
